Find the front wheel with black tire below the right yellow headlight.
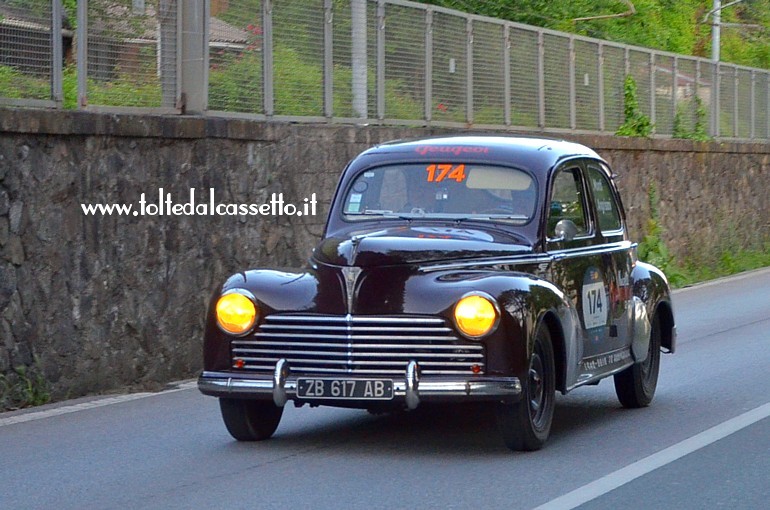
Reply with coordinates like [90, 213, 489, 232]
[497, 324, 556, 451]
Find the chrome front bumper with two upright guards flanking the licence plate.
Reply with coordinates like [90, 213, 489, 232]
[198, 359, 521, 409]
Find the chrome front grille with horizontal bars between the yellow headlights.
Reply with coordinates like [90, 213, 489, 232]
[232, 315, 485, 376]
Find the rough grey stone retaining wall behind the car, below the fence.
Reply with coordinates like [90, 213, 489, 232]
[0, 109, 770, 397]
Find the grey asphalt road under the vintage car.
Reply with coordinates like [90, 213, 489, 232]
[0, 270, 770, 509]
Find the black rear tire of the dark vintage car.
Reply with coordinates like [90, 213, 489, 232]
[615, 314, 661, 409]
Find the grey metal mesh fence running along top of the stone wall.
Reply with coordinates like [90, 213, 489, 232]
[0, 0, 770, 140]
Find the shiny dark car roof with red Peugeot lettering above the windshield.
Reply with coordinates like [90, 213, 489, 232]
[361, 135, 602, 171]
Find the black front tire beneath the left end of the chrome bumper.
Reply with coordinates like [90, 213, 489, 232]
[219, 398, 283, 441]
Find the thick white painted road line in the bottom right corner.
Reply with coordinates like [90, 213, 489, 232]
[534, 403, 770, 510]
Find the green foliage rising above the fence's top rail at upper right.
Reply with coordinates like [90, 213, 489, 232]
[423, 0, 770, 69]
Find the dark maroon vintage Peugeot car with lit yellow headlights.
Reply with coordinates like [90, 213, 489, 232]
[198, 136, 676, 450]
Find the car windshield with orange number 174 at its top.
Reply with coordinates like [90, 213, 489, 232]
[343, 163, 537, 224]
